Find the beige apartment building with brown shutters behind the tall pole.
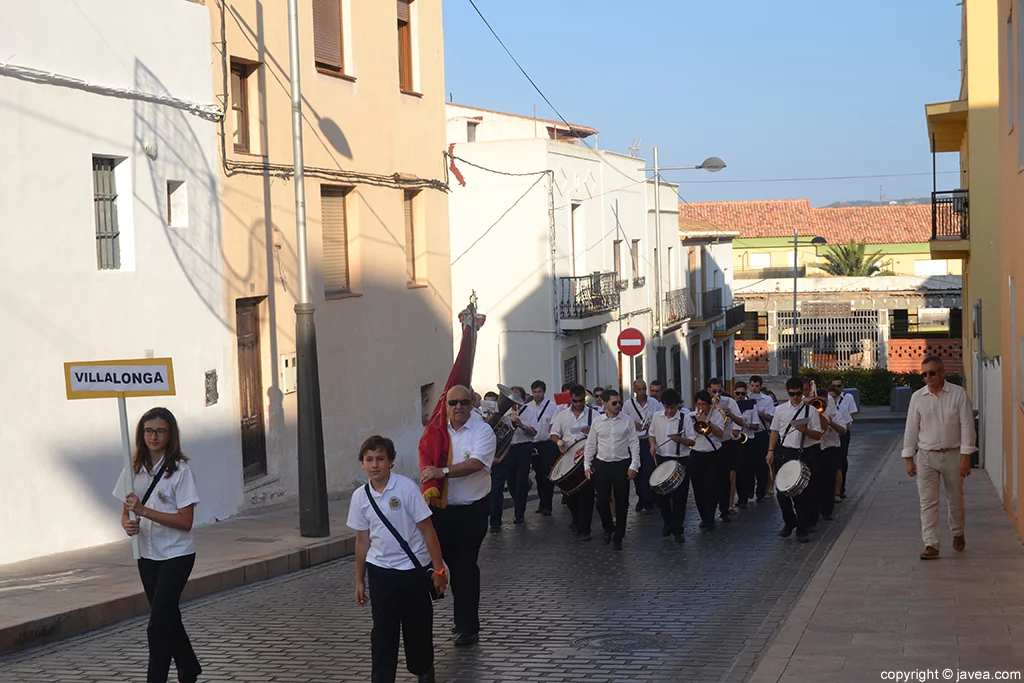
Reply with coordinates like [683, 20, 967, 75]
[210, 0, 452, 507]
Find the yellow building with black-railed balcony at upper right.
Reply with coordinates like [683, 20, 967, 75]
[925, 0, 1006, 402]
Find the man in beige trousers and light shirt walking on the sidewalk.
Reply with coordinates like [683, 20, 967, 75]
[903, 355, 977, 560]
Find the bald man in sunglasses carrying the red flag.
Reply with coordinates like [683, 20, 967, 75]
[420, 385, 497, 645]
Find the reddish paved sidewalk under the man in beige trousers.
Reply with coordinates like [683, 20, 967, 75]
[750, 440, 1024, 683]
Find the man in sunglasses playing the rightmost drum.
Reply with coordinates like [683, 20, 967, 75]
[766, 377, 821, 543]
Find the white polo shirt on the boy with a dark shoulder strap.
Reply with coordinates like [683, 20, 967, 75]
[347, 472, 430, 569]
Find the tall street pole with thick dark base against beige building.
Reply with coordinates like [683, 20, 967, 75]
[288, 0, 331, 538]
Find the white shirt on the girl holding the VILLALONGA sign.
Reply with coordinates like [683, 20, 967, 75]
[113, 458, 199, 560]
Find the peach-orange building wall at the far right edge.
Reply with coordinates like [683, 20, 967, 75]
[991, 0, 1024, 539]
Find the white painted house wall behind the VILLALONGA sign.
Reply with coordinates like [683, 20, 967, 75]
[0, 0, 242, 563]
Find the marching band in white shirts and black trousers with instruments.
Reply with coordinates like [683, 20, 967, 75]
[473, 375, 857, 550]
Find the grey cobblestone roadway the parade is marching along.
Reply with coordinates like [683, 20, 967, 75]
[0, 423, 902, 683]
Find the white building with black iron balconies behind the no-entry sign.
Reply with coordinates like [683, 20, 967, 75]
[447, 104, 731, 403]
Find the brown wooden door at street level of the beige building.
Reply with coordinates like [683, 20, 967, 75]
[234, 299, 266, 480]
